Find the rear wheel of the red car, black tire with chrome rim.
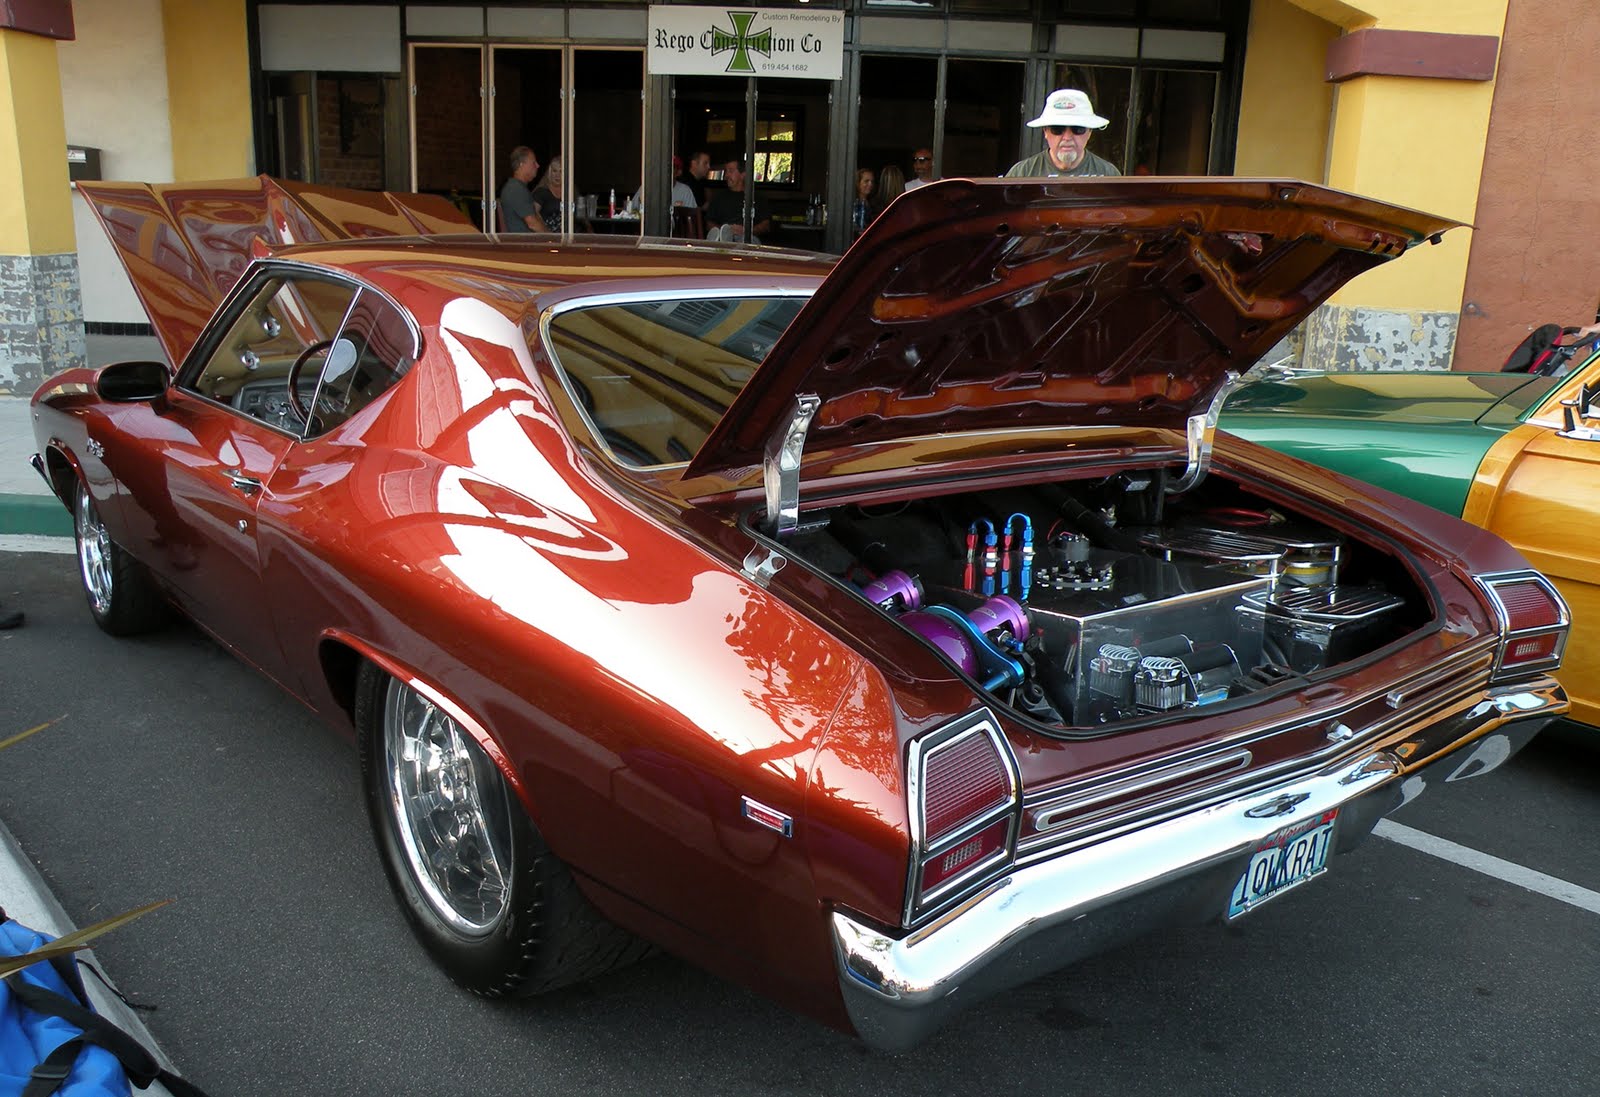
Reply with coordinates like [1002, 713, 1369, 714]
[355, 664, 650, 998]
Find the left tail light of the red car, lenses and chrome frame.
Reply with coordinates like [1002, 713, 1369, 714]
[906, 712, 1021, 924]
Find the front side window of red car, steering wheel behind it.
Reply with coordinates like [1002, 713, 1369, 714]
[178, 275, 357, 435]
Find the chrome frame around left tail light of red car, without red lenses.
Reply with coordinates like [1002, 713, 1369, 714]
[904, 708, 1022, 926]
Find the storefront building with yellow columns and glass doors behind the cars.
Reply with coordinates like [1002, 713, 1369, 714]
[0, 0, 1600, 393]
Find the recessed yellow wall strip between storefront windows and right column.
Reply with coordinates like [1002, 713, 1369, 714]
[1234, 0, 1339, 182]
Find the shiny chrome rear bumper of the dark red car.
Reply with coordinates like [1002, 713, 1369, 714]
[832, 678, 1566, 1052]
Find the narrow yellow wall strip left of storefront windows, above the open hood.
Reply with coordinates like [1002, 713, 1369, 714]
[162, 0, 256, 182]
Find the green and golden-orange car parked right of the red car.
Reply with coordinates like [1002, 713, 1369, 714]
[1219, 355, 1600, 726]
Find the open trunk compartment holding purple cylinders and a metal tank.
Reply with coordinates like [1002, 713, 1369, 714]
[784, 469, 1429, 729]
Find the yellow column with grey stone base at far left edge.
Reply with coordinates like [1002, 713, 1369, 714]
[0, 16, 86, 395]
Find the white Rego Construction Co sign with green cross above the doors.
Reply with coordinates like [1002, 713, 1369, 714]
[646, 5, 845, 80]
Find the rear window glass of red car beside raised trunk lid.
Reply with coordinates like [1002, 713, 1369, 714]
[547, 296, 805, 467]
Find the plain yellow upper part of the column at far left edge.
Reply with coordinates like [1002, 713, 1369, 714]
[0, 30, 77, 256]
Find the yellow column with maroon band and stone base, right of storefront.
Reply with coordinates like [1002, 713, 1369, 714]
[1294, 0, 1507, 369]
